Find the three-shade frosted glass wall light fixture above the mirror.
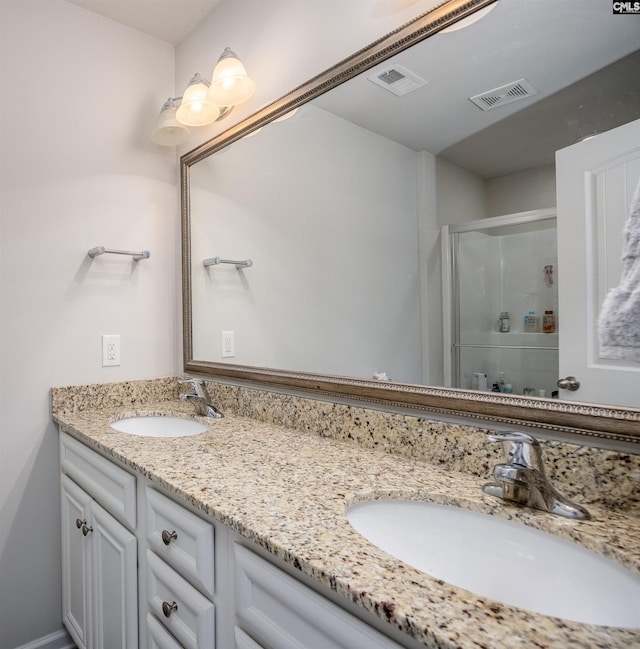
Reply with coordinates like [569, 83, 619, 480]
[151, 47, 256, 146]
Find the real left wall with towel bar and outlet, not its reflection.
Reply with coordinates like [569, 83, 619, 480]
[0, 0, 181, 649]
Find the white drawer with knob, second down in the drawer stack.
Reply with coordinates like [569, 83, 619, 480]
[147, 551, 215, 649]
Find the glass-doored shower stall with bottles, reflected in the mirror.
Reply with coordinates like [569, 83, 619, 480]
[442, 208, 561, 397]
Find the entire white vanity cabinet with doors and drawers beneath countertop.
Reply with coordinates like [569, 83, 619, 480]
[60, 433, 415, 649]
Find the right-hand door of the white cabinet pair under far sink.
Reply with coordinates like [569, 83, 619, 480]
[90, 502, 138, 649]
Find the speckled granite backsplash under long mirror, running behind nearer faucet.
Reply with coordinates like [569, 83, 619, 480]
[208, 382, 640, 515]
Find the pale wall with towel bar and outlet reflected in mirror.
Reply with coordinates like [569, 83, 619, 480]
[191, 105, 422, 383]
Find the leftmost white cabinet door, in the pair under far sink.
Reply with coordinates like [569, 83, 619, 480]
[61, 475, 91, 649]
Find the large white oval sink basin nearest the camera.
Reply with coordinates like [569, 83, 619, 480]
[347, 500, 640, 628]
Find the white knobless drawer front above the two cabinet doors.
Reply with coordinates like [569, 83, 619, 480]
[60, 433, 136, 529]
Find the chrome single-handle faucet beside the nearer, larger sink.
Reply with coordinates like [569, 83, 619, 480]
[482, 432, 591, 520]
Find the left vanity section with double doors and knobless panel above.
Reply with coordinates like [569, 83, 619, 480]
[60, 436, 138, 649]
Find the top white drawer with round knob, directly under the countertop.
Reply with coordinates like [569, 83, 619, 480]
[146, 487, 215, 597]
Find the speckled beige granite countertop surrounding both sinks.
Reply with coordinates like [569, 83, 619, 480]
[54, 401, 640, 649]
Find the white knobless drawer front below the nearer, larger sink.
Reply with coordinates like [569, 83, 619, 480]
[235, 544, 401, 649]
